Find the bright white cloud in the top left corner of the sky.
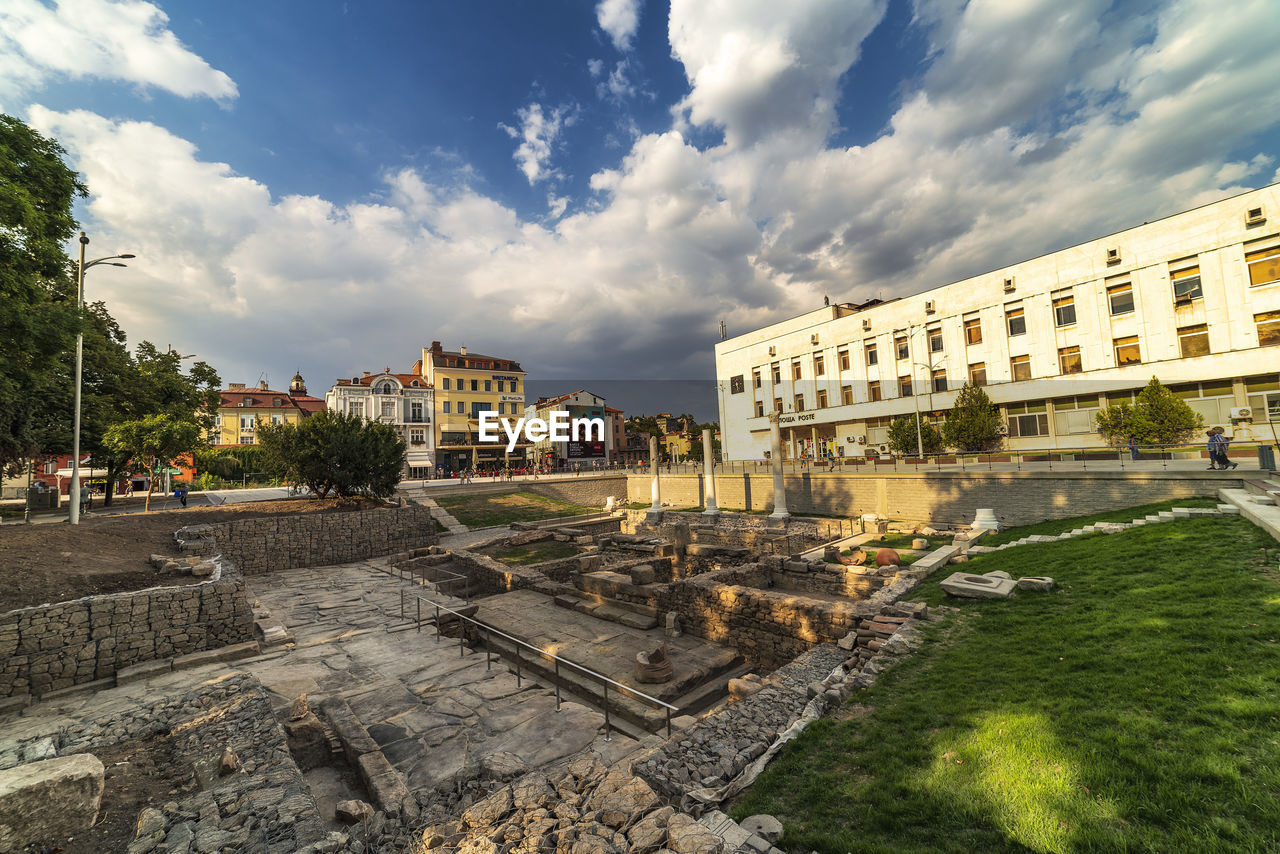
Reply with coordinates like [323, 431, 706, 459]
[0, 0, 238, 108]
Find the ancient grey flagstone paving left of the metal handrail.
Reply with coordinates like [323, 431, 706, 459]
[239, 561, 639, 789]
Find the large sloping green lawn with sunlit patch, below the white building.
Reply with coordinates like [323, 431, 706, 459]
[731, 512, 1280, 854]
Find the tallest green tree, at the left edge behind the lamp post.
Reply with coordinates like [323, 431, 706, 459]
[0, 115, 86, 470]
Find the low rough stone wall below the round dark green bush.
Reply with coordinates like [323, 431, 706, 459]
[177, 506, 439, 575]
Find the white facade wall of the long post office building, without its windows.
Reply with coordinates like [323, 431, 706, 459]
[716, 184, 1280, 460]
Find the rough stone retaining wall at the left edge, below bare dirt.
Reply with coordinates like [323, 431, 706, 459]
[0, 561, 253, 697]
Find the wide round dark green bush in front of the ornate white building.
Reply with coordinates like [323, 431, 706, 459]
[257, 410, 404, 498]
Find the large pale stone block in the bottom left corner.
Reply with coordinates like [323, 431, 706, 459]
[0, 753, 102, 851]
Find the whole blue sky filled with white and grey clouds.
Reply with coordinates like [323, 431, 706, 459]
[0, 0, 1280, 417]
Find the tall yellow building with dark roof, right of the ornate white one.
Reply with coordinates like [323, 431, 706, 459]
[413, 341, 531, 471]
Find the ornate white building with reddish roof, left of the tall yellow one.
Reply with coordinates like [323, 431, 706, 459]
[324, 367, 435, 480]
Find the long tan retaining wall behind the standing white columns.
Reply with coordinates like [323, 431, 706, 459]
[627, 471, 1240, 526]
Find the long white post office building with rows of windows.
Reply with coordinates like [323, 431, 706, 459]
[716, 184, 1280, 460]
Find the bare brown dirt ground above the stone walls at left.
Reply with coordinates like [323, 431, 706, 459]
[0, 498, 383, 613]
